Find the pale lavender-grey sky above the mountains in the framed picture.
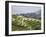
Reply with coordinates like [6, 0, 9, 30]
[11, 5, 41, 14]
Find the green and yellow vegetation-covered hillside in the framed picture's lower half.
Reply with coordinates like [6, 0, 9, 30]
[12, 15, 41, 31]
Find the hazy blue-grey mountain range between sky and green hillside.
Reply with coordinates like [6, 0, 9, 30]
[16, 10, 41, 19]
